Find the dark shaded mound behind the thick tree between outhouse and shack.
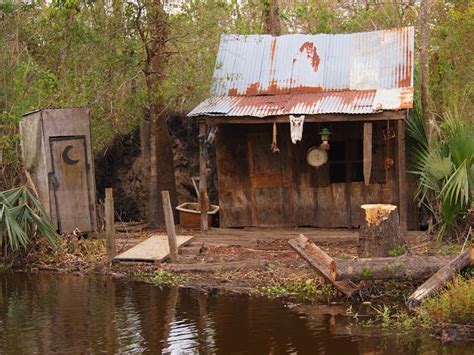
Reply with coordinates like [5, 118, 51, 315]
[95, 112, 218, 221]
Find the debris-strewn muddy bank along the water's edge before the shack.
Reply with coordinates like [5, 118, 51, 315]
[14, 228, 452, 302]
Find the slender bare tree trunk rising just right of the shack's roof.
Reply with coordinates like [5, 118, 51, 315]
[419, 0, 431, 134]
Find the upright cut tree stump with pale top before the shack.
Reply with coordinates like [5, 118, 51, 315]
[357, 204, 404, 258]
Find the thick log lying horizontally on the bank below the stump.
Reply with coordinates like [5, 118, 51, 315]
[336, 255, 451, 281]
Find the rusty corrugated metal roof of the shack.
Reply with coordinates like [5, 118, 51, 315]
[189, 27, 414, 117]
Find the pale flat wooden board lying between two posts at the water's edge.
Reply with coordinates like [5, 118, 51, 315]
[113, 234, 194, 263]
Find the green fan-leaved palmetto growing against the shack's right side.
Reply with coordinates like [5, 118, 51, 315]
[407, 110, 474, 239]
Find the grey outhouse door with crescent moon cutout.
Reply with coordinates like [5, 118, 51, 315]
[50, 137, 92, 233]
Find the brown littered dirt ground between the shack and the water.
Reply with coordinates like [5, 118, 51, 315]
[19, 224, 470, 301]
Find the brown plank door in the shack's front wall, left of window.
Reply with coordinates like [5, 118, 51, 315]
[247, 125, 296, 226]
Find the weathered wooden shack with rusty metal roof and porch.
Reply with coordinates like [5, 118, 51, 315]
[189, 27, 414, 234]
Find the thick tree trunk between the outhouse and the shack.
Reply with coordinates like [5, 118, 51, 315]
[142, 0, 177, 227]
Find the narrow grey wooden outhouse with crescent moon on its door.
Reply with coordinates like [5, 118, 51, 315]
[20, 108, 97, 233]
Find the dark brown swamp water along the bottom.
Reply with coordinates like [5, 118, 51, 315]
[0, 272, 473, 354]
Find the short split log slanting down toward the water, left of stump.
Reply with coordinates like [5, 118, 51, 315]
[288, 234, 359, 297]
